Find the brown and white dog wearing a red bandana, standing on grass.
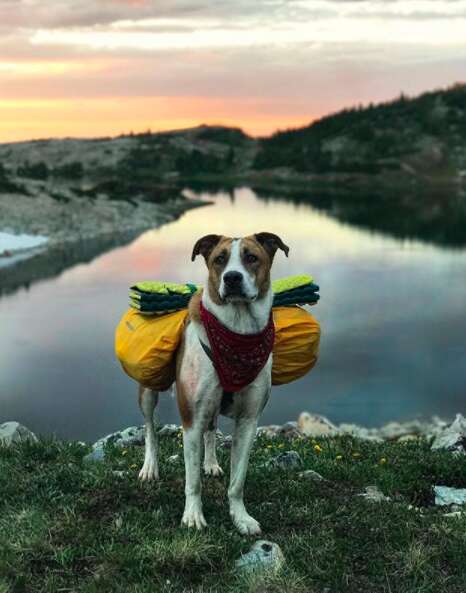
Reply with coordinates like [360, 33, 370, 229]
[139, 232, 289, 535]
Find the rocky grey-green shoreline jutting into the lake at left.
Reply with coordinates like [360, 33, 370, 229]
[0, 194, 209, 296]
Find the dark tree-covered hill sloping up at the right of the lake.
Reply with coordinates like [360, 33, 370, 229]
[253, 84, 466, 177]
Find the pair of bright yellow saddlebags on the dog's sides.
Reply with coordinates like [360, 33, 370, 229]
[115, 306, 320, 391]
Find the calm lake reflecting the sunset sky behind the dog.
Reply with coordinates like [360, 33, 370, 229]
[0, 188, 466, 440]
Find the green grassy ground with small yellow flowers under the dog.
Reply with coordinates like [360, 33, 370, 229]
[0, 430, 466, 593]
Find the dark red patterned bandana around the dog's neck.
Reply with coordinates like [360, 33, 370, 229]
[200, 302, 275, 393]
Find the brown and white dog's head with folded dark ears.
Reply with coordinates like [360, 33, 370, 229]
[191, 233, 289, 305]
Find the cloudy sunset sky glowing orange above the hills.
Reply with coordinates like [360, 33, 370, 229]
[0, 0, 466, 142]
